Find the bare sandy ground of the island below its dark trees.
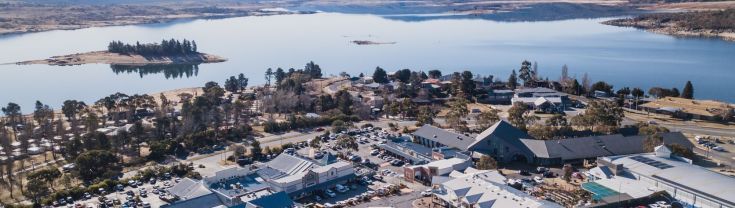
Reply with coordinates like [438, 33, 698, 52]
[15, 51, 227, 66]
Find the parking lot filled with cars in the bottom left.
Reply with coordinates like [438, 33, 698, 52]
[66, 177, 180, 208]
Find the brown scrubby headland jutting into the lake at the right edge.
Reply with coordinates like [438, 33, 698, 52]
[603, 9, 735, 41]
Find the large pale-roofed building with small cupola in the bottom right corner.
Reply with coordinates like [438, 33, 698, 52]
[582, 146, 735, 208]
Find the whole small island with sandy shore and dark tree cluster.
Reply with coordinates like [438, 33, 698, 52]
[16, 39, 227, 66]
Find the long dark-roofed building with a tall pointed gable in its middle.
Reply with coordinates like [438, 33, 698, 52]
[413, 120, 694, 165]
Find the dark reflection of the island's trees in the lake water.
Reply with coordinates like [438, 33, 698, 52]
[110, 64, 199, 79]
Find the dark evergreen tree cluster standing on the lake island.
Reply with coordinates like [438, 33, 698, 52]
[107, 39, 197, 56]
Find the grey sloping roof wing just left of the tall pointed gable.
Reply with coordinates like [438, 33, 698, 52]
[413, 124, 475, 150]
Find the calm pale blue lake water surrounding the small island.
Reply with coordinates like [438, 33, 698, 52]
[0, 13, 735, 109]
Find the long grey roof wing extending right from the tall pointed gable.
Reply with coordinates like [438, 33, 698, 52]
[521, 132, 692, 160]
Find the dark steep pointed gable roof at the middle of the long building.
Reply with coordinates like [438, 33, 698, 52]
[472, 120, 533, 153]
